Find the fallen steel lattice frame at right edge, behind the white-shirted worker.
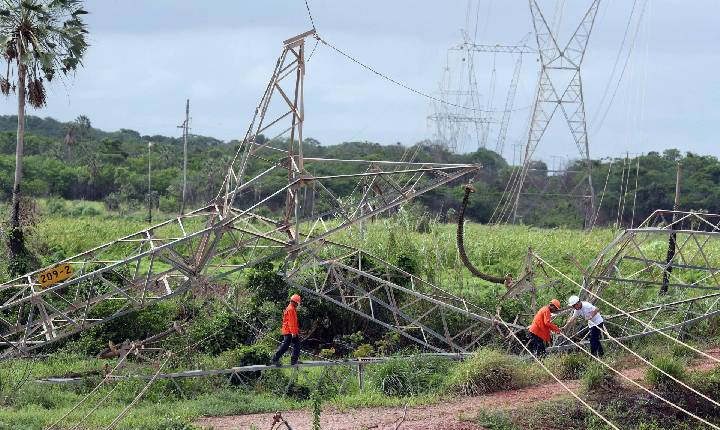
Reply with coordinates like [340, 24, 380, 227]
[559, 210, 720, 347]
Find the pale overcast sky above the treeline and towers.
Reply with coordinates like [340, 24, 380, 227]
[2, 0, 720, 166]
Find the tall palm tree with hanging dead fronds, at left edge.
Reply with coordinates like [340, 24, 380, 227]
[0, 0, 88, 275]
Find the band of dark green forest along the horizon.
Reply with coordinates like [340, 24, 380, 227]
[0, 116, 720, 227]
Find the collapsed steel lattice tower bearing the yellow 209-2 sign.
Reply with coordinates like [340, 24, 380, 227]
[0, 30, 524, 357]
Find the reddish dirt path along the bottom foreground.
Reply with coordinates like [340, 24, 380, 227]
[194, 350, 720, 430]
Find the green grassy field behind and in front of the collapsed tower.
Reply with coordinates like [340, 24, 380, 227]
[0, 201, 712, 430]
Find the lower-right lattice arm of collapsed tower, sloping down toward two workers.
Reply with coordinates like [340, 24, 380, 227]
[291, 249, 523, 352]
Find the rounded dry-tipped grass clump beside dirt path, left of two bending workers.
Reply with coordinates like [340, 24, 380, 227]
[448, 349, 531, 396]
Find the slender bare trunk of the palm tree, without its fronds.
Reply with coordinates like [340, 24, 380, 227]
[8, 55, 27, 275]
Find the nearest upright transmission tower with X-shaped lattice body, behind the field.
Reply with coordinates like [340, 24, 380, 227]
[512, 0, 600, 226]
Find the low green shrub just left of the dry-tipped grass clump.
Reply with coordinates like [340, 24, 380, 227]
[370, 357, 449, 396]
